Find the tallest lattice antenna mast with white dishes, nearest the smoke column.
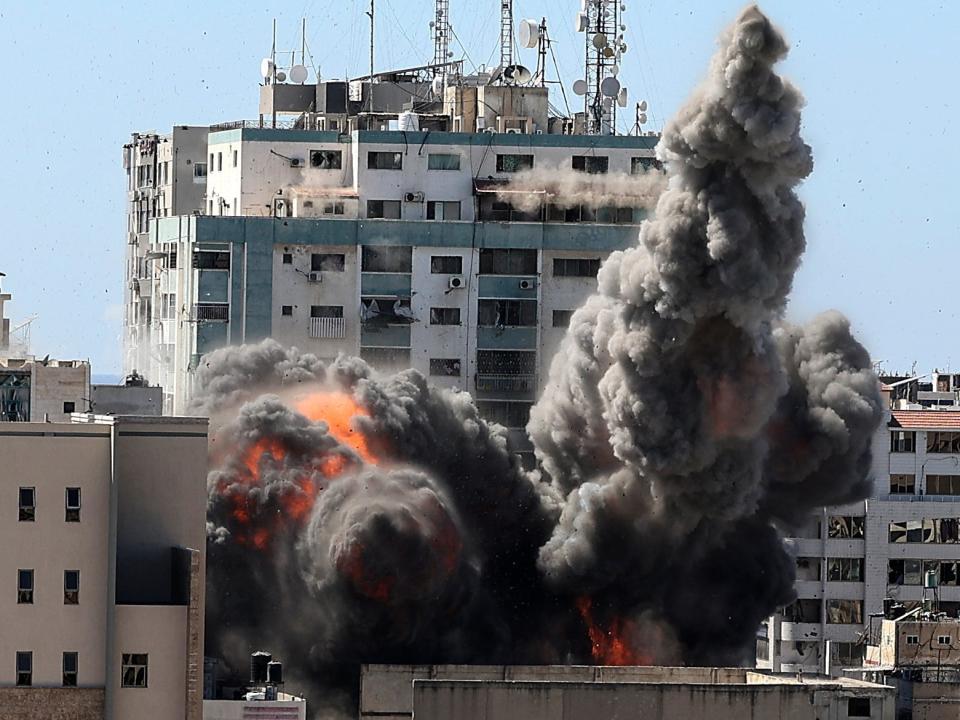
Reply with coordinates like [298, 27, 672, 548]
[573, 0, 627, 135]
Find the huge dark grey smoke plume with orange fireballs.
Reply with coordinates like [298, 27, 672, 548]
[197, 8, 882, 716]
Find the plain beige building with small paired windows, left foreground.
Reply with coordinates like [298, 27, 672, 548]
[0, 415, 207, 720]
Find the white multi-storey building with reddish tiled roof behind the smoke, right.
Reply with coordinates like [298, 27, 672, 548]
[757, 372, 960, 674]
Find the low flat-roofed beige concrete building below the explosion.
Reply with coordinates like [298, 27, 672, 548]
[360, 665, 895, 720]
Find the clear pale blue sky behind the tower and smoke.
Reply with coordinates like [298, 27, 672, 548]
[0, 0, 960, 373]
